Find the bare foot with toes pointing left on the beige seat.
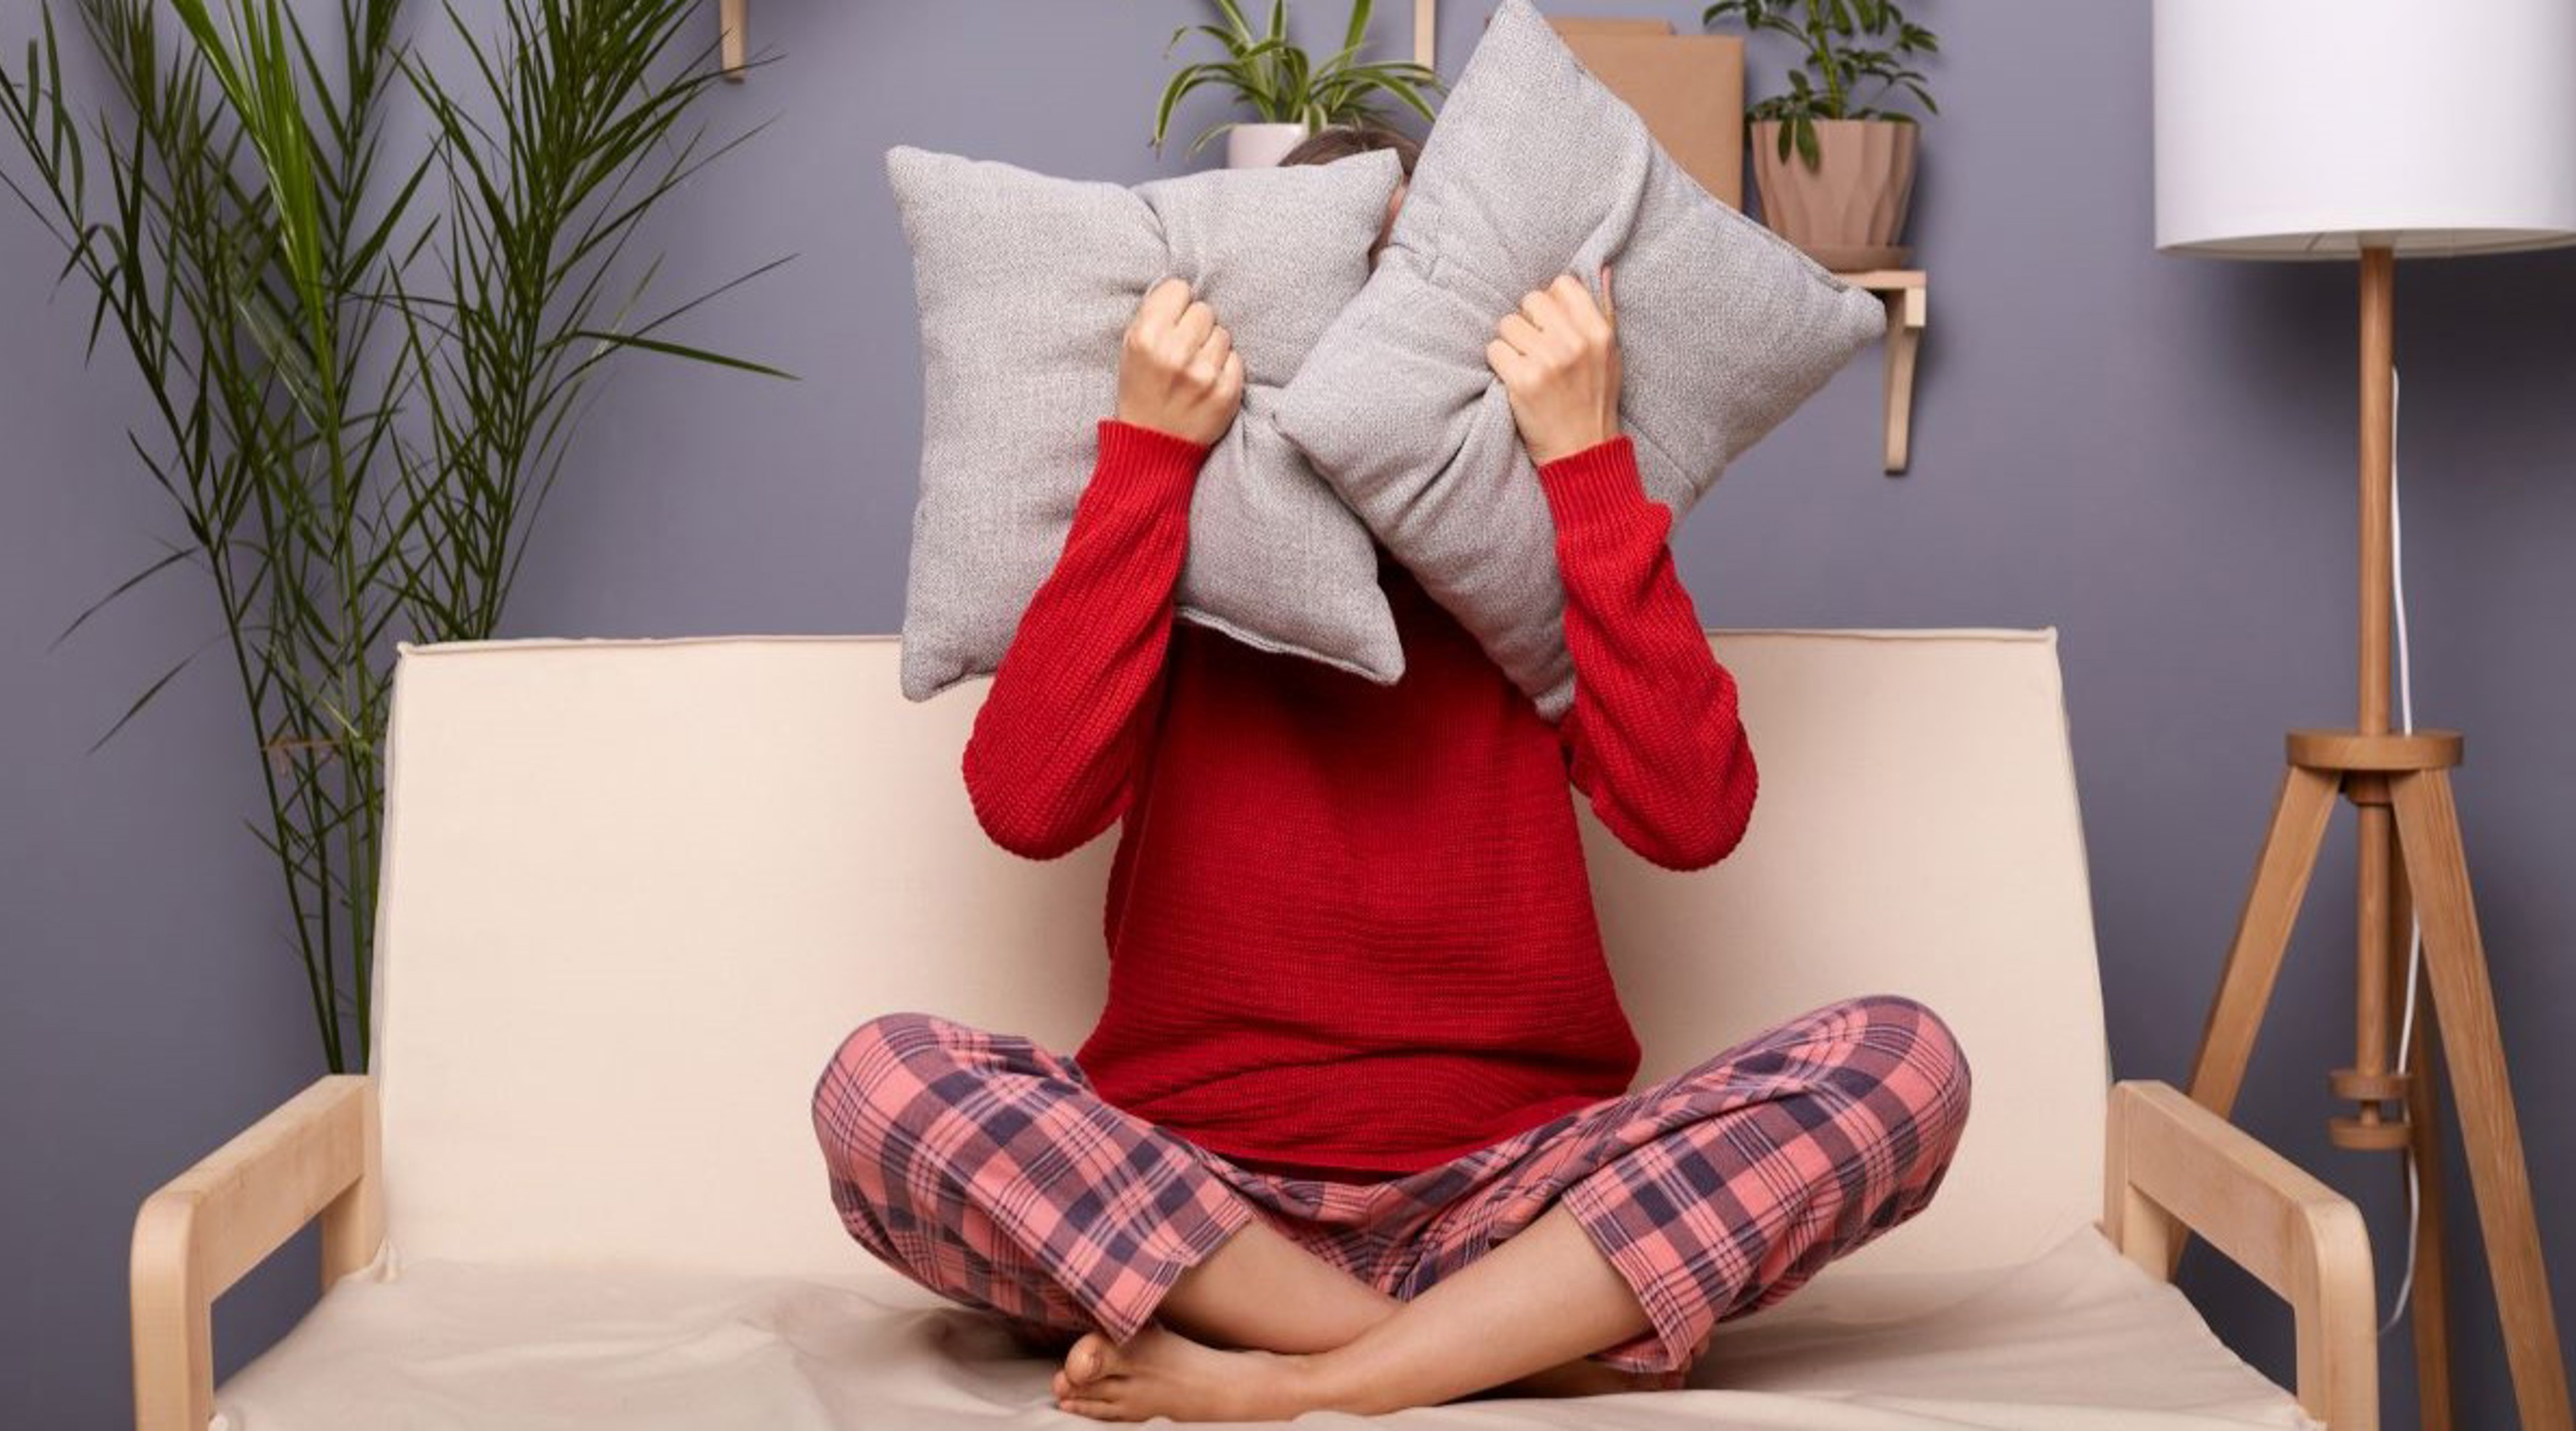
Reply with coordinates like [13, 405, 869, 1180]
[1056, 1323, 1324, 1421]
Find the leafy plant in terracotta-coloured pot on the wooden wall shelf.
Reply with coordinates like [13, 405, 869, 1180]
[1700, 0, 1940, 271]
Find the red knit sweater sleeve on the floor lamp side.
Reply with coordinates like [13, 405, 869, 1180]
[1538, 433, 1760, 869]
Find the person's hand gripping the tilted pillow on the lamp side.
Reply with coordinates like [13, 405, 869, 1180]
[1484, 263, 1618, 467]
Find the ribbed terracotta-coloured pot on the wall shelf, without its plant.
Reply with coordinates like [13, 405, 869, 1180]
[1752, 119, 1919, 271]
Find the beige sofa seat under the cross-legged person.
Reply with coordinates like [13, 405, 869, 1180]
[214, 1227, 2318, 1431]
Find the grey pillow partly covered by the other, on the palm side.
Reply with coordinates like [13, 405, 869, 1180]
[886, 147, 1404, 701]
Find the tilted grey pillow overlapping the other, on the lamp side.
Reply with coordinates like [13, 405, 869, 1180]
[1278, 0, 1886, 719]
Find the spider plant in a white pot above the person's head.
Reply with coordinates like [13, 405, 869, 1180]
[1154, 0, 1442, 168]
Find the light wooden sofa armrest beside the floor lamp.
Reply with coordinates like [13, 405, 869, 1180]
[2102, 1077, 2380, 1431]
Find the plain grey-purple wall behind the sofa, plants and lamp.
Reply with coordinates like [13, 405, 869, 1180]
[0, 0, 2576, 1426]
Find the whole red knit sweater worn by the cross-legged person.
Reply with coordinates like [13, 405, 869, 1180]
[963, 420, 1754, 1178]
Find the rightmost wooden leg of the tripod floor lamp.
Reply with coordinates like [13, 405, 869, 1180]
[2388, 768, 2571, 1431]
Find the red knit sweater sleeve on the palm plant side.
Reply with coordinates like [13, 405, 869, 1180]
[963, 418, 1208, 859]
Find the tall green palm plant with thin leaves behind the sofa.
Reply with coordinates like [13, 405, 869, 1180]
[0, 0, 773, 1070]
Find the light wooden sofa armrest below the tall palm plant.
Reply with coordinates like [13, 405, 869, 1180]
[131, 1073, 384, 1431]
